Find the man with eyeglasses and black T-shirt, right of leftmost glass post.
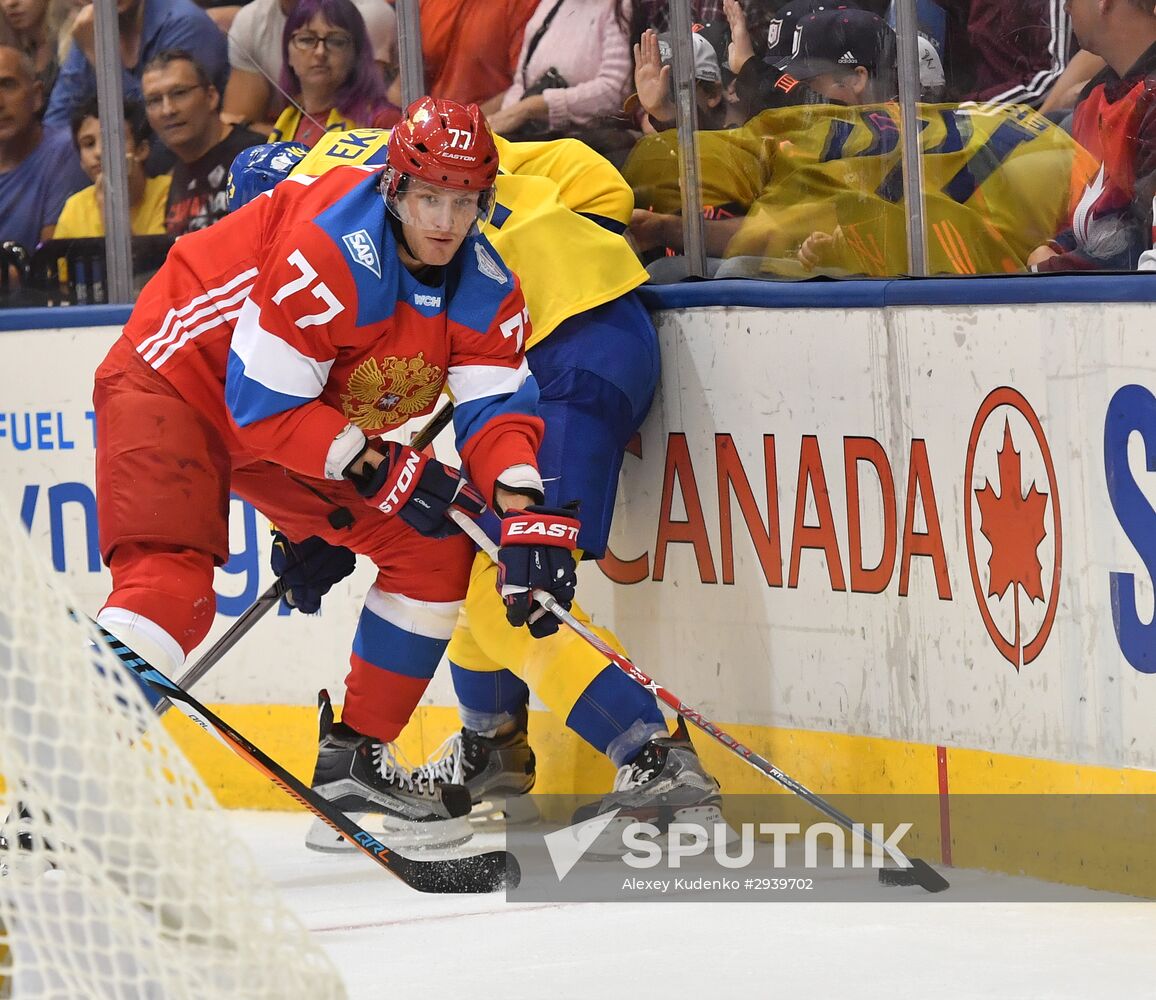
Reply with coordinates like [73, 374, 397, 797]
[141, 49, 265, 236]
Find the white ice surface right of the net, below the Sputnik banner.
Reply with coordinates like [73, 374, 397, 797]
[235, 813, 1156, 1000]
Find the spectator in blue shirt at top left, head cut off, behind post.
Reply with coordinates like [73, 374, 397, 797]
[44, 0, 229, 128]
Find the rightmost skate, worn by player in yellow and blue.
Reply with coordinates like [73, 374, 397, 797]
[572, 718, 734, 855]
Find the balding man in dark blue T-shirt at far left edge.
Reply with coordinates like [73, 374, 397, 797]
[0, 46, 87, 250]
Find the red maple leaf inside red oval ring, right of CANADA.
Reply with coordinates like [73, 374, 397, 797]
[964, 387, 1061, 671]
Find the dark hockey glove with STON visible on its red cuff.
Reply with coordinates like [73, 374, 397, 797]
[354, 440, 486, 539]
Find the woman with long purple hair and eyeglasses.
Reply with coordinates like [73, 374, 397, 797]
[269, 0, 401, 148]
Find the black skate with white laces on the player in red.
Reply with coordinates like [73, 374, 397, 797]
[305, 690, 472, 852]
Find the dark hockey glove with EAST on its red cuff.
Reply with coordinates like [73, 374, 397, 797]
[498, 504, 579, 639]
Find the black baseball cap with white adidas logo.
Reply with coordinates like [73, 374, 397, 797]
[778, 8, 895, 80]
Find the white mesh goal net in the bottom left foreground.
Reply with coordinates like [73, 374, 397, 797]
[0, 508, 344, 1000]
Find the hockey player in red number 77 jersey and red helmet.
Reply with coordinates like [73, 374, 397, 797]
[94, 98, 577, 843]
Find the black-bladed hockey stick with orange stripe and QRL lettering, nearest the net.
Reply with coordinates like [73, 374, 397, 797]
[89, 620, 521, 892]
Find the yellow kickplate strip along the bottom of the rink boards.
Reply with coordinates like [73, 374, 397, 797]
[165, 705, 1156, 897]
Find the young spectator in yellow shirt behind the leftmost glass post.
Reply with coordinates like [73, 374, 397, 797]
[54, 98, 171, 239]
